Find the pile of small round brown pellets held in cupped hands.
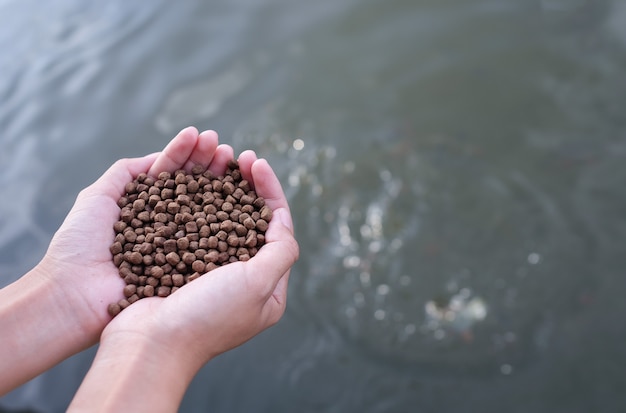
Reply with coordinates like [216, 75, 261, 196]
[108, 160, 272, 317]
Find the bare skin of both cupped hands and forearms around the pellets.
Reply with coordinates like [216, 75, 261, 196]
[0, 128, 299, 412]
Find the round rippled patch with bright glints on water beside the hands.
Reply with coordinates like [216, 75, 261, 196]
[274, 137, 586, 375]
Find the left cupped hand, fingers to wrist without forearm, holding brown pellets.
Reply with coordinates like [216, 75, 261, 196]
[38, 127, 224, 344]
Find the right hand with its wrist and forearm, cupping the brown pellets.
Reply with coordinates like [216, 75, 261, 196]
[68, 128, 299, 412]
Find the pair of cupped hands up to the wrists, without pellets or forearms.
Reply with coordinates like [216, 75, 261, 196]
[39, 127, 299, 368]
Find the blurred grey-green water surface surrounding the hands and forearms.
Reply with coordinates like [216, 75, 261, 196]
[0, 0, 626, 413]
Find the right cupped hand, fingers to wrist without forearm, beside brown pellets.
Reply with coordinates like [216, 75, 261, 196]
[102, 145, 299, 368]
